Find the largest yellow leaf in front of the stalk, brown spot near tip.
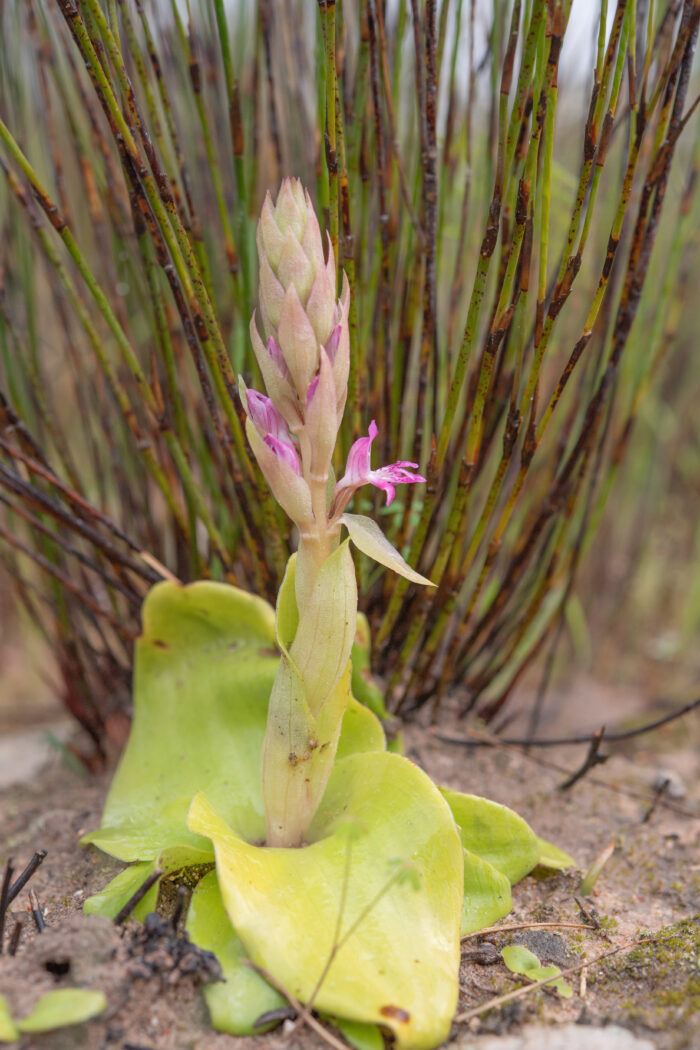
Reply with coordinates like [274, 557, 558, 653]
[189, 752, 464, 1050]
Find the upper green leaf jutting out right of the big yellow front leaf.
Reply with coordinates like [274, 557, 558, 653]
[443, 790, 540, 885]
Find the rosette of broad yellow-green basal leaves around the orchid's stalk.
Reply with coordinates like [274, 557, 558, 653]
[83, 579, 570, 1050]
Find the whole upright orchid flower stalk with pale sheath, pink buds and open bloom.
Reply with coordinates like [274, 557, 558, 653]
[240, 179, 429, 846]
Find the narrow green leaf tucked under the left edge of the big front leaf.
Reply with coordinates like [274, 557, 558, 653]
[187, 872, 287, 1035]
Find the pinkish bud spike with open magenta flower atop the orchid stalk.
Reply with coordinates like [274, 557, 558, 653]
[241, 179, 423, 599]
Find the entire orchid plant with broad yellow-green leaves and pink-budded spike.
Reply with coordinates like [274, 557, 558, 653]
[84, 180, 572, 1050]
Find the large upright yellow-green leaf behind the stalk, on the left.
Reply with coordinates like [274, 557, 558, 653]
[82, 582, 383, 861]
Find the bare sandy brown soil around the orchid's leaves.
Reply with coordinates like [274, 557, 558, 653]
[0, 684, 700, 1050]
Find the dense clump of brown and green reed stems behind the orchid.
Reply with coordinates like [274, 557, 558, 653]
[0, 0, 700, 757]
